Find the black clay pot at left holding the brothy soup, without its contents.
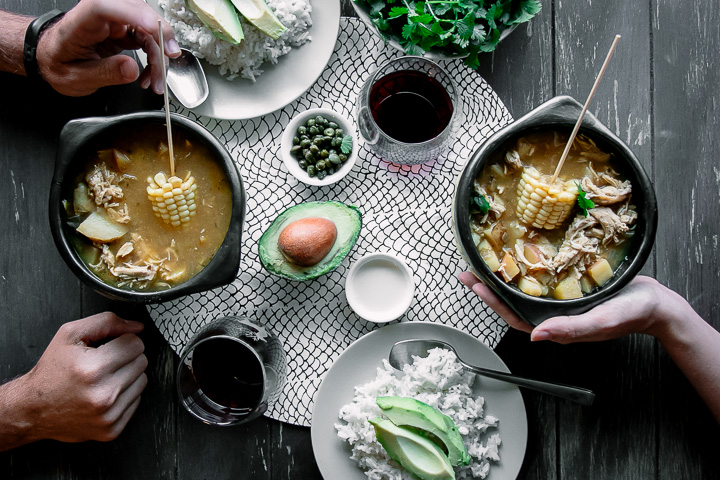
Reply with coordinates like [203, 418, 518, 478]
[49, 112, 245, 303]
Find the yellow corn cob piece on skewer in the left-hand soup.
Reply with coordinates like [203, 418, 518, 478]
[147, 172, 197, 227]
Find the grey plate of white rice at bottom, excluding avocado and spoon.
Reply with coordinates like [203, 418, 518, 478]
[311, 322, 527, 480]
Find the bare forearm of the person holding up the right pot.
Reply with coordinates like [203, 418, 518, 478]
[654, 292, 720, 422]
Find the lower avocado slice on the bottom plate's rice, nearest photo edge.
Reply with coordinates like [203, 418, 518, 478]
[370, 417, 455, 480]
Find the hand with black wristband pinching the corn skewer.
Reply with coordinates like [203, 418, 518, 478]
[37, 0, 180, 96]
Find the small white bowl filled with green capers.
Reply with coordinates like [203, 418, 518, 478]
[280, 108, 358, 186]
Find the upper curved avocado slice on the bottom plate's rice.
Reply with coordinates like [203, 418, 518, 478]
[375, 397, 470, 465]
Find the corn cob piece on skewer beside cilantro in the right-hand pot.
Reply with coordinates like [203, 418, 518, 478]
[517, 167, 578, 230]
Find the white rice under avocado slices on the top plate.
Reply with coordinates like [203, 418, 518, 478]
[159, 0, 312, 81]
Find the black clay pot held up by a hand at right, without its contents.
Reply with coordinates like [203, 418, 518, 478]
[453, 97, 657, 325]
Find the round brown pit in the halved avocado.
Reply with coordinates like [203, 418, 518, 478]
[278, 217, 337, 267]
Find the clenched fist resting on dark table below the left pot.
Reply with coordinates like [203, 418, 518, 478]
[14, 312, 148, 442]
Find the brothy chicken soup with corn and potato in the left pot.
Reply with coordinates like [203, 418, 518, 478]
[66, 125, 232, 291]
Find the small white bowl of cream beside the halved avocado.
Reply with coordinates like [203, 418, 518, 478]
[345, 252, 415, 323]
